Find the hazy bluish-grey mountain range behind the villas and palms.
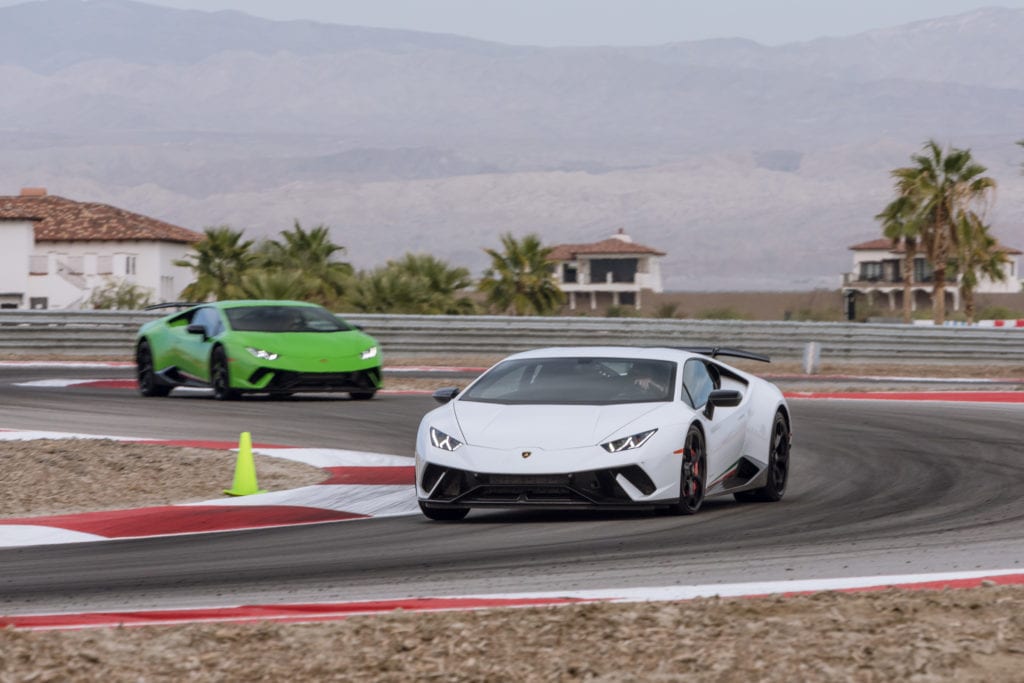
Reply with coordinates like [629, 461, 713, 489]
[0, 0, 1024, 290]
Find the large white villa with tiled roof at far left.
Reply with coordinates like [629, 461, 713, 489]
[0, 187, 203, 309]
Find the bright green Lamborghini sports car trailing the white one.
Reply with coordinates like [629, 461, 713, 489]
[135, 301, 381, 400]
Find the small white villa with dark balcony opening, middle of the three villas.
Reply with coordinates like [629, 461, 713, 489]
[550, 228, 665, 310]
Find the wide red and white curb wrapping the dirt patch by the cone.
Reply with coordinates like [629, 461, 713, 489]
[0, 431, 419, 547]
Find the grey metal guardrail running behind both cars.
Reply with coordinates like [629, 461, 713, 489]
[0, 310, 1024, 365]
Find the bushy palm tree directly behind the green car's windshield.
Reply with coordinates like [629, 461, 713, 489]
[259, 220, 353, 305]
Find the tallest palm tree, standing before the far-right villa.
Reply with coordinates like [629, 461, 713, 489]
[892, 140, 995, 325]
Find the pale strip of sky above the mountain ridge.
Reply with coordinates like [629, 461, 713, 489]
[6, 0, 1024, 45]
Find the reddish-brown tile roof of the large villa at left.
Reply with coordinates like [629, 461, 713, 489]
[0, 193, 203, 244]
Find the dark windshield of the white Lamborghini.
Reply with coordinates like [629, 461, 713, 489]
[459, 357, 676, 405]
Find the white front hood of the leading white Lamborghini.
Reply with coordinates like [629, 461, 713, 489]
[452, 400, 666, 450]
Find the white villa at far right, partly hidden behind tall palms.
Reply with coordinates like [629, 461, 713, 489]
[843, 238, 1022, 310]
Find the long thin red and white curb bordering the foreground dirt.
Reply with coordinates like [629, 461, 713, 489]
[0, 569, 1024, 631]
